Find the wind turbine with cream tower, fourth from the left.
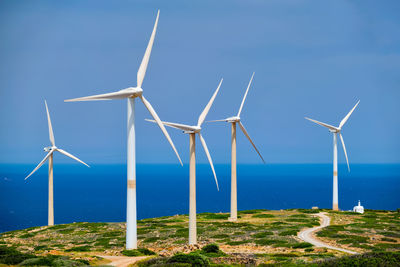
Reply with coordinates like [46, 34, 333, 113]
[209, 72, 265, 221]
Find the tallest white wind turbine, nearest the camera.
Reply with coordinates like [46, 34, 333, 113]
[65, 10, 183, 249]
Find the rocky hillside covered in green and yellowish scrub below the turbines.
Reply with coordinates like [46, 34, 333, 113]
[0, 209, 400, 266]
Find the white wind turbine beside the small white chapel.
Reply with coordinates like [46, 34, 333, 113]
[305, 100, 360, 210]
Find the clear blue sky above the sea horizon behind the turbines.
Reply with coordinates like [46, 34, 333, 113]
[0, 0, 400, 164]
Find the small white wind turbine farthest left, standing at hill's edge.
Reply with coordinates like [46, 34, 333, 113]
[25, 100, 89, 226]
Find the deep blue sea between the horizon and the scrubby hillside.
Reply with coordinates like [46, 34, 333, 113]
[0, 164, 400, 232]
